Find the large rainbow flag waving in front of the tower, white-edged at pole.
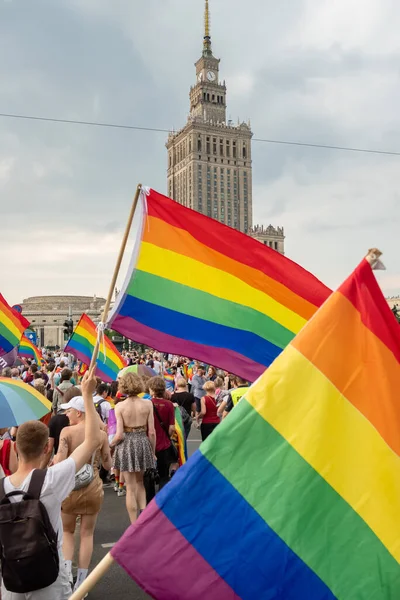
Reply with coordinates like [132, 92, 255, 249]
[109, 190, 331, 381]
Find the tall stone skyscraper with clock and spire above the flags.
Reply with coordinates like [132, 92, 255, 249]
[167, 0, 285, 253]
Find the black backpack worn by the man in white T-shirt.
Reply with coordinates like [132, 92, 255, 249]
[0, 469, 60, 594]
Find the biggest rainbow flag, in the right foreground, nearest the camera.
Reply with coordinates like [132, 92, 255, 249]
[111, 261, 400, 600]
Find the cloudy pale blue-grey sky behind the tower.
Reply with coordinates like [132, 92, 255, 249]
[0, 0, 400, 303]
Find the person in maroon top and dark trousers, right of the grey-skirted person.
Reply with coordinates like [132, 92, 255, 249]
[149, 377, 177, 489]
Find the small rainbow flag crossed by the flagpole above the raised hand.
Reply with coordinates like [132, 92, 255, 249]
[64, 314, 126, 383]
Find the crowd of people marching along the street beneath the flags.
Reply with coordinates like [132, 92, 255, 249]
[0, 351, 248, 600]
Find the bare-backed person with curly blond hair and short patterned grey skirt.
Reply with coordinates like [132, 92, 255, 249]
[111, 373, 156, 523]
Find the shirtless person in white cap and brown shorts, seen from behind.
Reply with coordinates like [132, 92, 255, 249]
[54, 396, 111, 590]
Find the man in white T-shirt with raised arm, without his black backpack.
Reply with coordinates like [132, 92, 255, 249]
[1, 372, 101, 600]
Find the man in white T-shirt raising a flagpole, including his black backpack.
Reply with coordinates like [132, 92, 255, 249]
[0, 371, 101, 600]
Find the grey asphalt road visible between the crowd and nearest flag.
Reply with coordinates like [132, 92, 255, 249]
[88, 428, 200, 600]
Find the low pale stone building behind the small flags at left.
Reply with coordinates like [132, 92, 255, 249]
[22, 296, 106, 348]
